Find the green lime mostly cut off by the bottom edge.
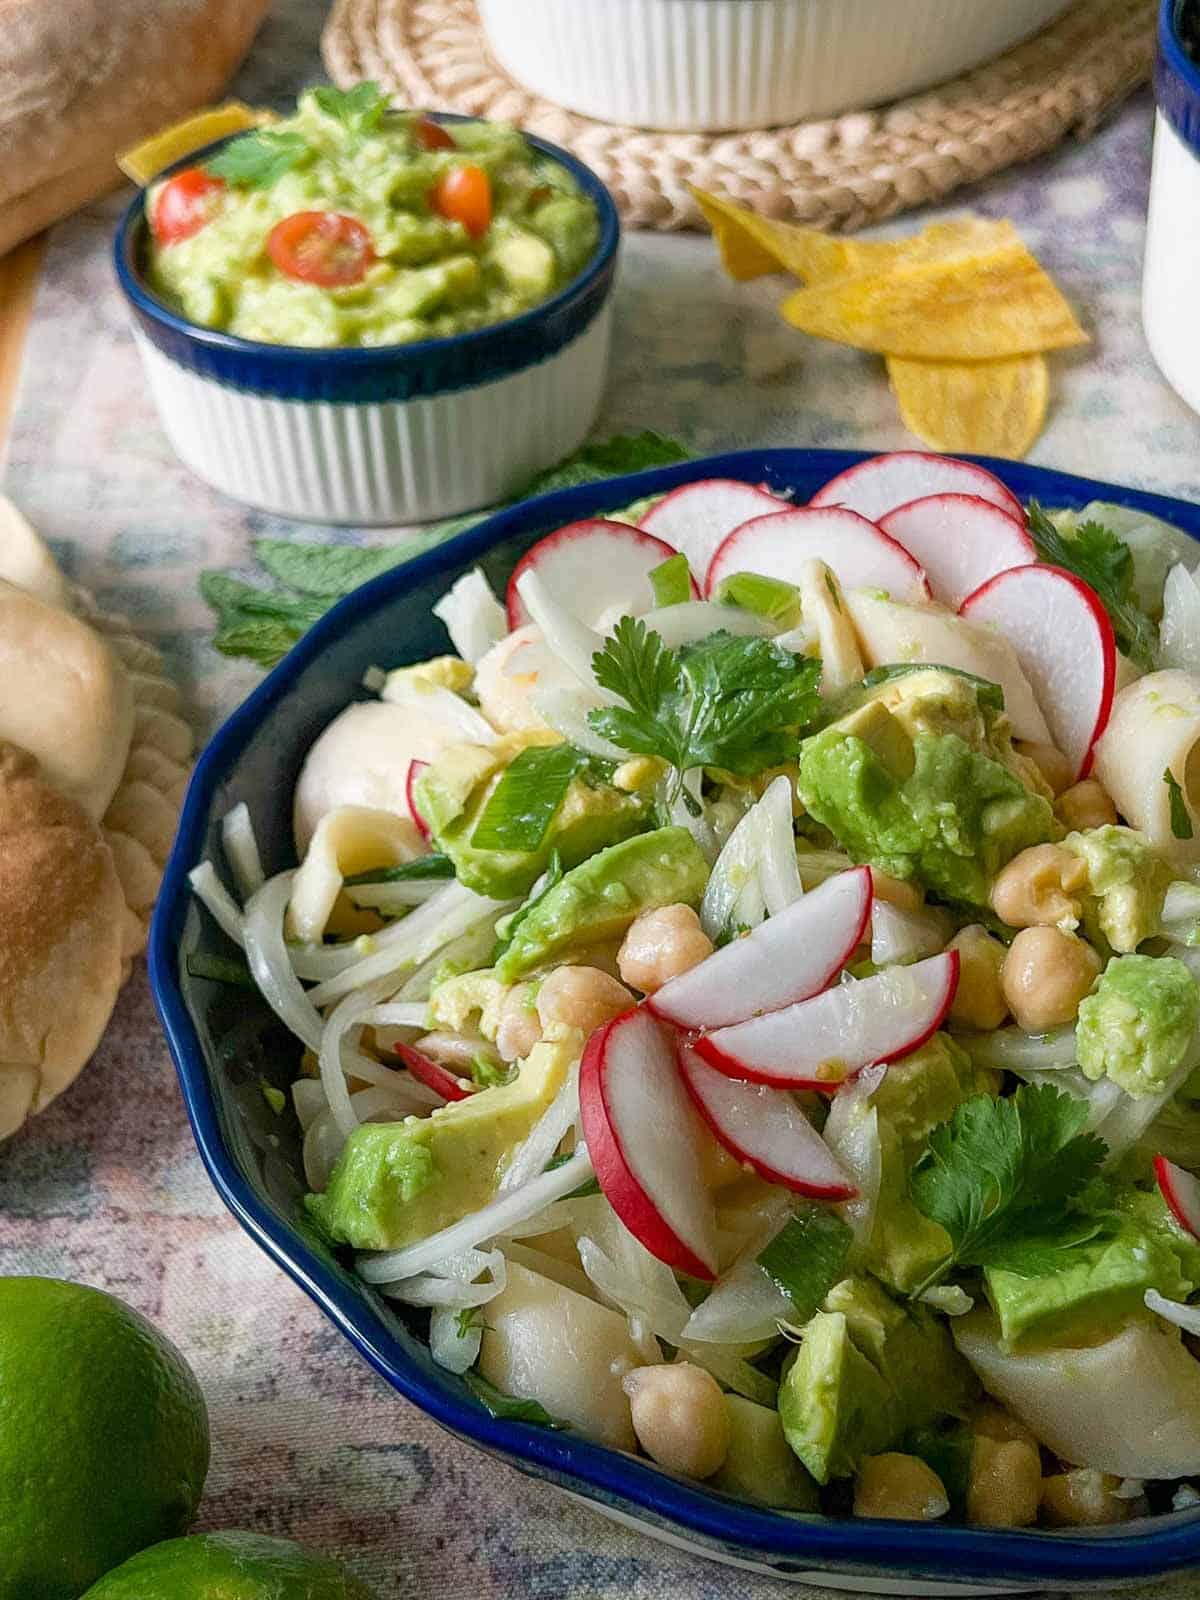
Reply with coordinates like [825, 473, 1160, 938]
[85, 1533, 374, 1600]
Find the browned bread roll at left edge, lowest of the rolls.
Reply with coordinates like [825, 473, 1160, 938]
[0, 742, 126, 1139]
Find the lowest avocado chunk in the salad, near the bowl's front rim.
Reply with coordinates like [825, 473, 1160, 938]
[779, 1277, 978, 1483]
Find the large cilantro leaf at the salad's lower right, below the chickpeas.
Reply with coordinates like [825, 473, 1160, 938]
[909, 1083, 1107, 1296]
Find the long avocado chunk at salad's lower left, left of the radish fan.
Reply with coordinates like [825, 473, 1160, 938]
[304, 1032, 581, 1250]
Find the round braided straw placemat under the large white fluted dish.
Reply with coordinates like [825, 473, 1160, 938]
[322, 0, 1157, 232]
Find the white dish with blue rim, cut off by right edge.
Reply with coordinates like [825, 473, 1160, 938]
[1142, 0, 1200, 411]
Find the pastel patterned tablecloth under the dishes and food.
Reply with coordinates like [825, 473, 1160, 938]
[0, 0, 1200, 1600]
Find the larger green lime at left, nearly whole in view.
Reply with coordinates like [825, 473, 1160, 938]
[0, 1278, 208, 1600]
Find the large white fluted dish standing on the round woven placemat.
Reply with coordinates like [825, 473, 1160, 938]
[478, 0, 1070, 131]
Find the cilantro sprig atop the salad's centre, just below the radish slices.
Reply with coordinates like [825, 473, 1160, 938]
[587, 616, 821, 813]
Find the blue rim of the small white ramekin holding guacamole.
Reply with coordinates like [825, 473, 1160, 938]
[114, 114, 621, 405]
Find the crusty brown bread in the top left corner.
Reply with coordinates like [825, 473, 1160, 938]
[0, 0, 267, 254]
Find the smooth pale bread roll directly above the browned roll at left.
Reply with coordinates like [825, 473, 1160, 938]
[0, 582, 133, 819]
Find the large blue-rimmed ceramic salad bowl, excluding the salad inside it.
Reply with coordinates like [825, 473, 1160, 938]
[150, 450, 1200, 1597]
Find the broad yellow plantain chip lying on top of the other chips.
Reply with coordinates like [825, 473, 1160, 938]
[779, 240, 1088, 362]
